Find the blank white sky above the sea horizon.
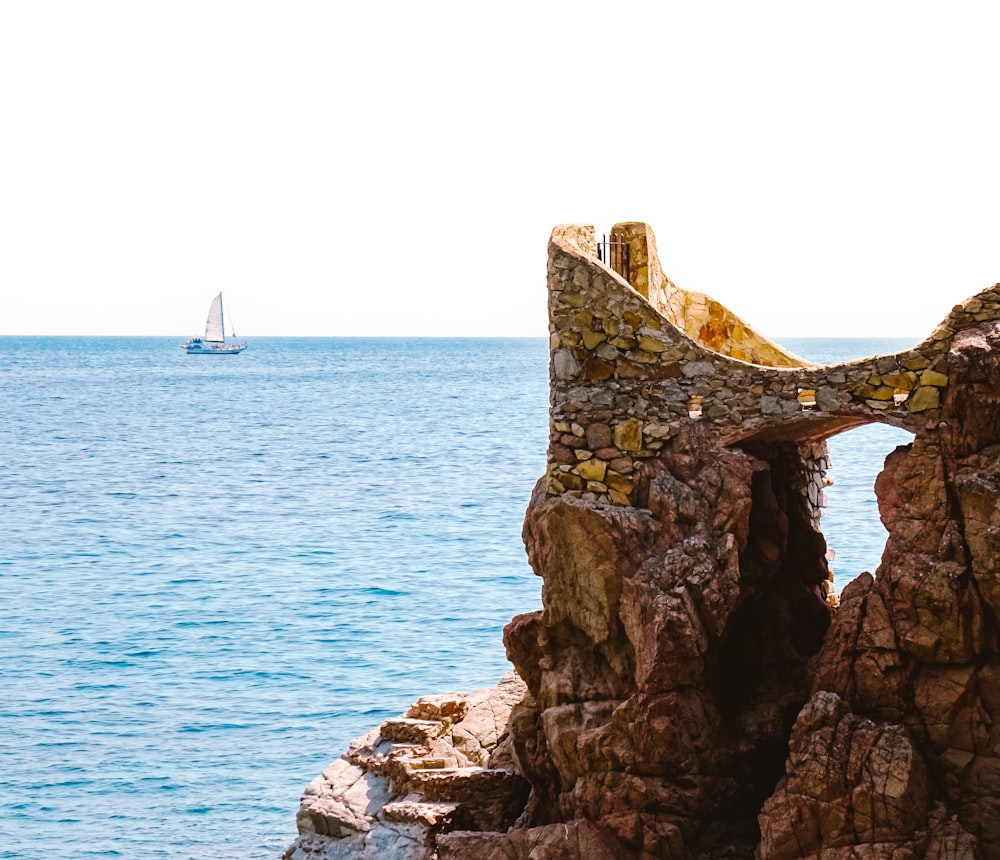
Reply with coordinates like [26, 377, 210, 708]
[0, 0, 1000, 340]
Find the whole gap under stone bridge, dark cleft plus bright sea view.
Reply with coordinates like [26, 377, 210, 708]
[713, 424, 912, 832]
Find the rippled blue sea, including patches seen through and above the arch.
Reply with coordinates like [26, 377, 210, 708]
[0, 337, 911, 860]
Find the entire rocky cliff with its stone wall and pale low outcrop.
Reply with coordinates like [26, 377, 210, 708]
[286, 223, 1000, 860]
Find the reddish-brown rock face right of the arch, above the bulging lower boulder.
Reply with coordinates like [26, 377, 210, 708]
[776, 323, 1000, 858]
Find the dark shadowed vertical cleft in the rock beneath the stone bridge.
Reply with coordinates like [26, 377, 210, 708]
[713, 441, 832, 821]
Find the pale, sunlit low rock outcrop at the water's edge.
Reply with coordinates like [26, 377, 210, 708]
[284, 672, 528, 860]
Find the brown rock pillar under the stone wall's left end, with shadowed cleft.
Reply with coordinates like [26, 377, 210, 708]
[500, 434, 832, 858]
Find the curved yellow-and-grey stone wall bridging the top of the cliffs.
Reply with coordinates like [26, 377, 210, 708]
[548, 222, 1000, 505]
